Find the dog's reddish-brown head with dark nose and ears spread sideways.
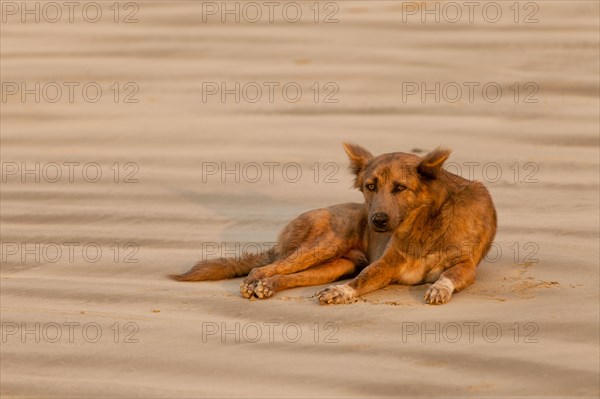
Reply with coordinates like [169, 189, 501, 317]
[344, 144, 450, 232]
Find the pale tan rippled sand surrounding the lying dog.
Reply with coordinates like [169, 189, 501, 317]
[0, 1, 600, 398]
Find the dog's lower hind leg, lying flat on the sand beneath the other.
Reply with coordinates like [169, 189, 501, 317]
[254, 250, 367, 299]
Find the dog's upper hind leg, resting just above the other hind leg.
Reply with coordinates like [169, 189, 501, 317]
[240, 238, 349, 298]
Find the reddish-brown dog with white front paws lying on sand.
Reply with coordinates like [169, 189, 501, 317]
[171, 143, 497, 305]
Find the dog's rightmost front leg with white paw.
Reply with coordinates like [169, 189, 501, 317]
[424, 260, 477, 305]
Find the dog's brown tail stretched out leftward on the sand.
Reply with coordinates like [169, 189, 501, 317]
[169, 248, 277, 281]
